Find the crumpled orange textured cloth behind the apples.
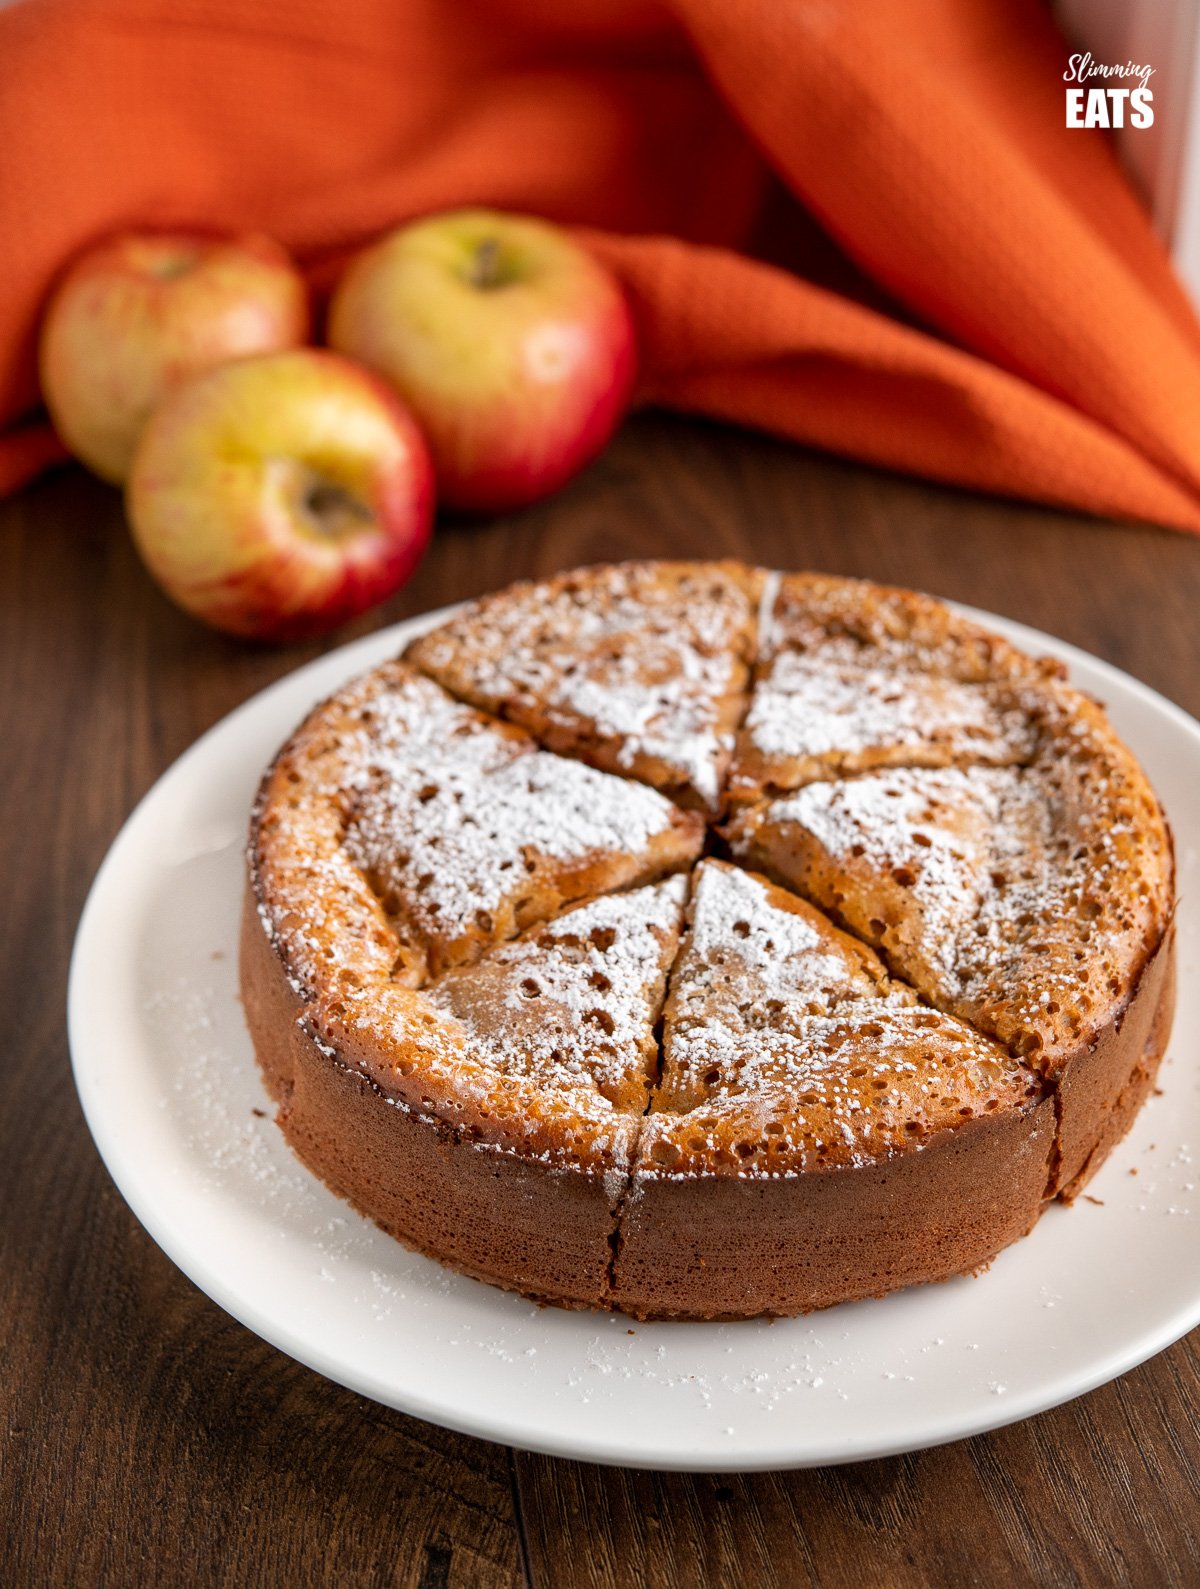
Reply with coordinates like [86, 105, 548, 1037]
[0, 0, 1200, 531]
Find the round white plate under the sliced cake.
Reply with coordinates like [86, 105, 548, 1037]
[70, 600, 1200, 1471]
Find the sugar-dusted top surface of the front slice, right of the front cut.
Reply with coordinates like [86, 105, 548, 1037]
[641, 861, 1039, 1174]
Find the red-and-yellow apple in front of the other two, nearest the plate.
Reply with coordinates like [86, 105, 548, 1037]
[126, 348, 434, 640]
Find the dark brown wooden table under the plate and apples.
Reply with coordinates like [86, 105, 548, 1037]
[0, 416, 1200, 1589]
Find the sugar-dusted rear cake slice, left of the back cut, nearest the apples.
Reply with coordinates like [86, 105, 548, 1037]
[405, 563, 760, 812]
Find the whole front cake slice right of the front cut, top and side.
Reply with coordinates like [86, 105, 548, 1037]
[614, 861, 1054, 1317]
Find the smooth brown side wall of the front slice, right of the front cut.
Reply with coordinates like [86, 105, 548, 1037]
[614, 1100, 1054, 1319]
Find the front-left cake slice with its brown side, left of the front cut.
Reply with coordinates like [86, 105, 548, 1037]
[284, 876, 687, 1308]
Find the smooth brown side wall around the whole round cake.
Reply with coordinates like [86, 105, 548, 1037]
[240, 882, 1175, 1320]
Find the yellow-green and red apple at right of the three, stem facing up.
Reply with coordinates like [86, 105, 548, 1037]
[329, 210, 636, 512]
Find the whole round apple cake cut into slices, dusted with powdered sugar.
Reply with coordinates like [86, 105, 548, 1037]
[242, 563, 1175, 1319]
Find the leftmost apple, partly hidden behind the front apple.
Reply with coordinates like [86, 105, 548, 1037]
[38, 232, 308, 485]
